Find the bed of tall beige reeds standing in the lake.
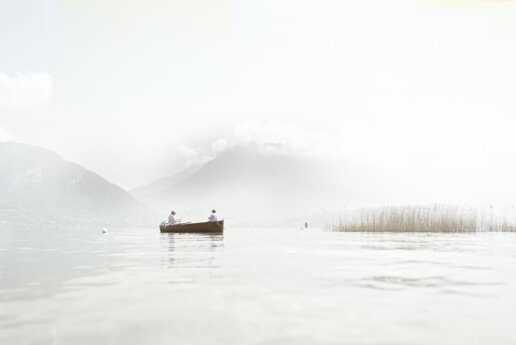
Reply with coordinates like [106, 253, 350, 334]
[333, 205, 516, 232]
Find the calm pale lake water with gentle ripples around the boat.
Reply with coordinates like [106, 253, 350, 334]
[0, 227, 516, 345]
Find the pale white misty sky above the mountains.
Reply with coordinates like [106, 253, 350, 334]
[0, 0, 516, 201]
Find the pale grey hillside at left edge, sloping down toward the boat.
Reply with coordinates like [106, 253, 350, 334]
[0, 142, 152, 223]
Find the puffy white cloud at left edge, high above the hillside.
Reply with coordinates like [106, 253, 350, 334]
[0, 73, 53, 111]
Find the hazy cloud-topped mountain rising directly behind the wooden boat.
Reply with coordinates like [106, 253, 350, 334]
[130, 148, 350, 224]
